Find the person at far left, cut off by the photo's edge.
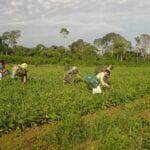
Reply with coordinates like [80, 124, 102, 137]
[0, 60, 10, 80]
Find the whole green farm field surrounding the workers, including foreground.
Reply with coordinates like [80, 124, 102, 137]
[0, 66, 150, 149]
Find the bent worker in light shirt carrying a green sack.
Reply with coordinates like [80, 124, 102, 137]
[84, 69, 110, 94]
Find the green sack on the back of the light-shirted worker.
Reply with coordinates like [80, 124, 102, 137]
[84, 76, 100, 88]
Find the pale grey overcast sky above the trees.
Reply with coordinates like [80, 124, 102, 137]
[0, 0, 150, 46]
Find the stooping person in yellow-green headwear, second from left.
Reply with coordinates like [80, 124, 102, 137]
[12, 63, 28, 83]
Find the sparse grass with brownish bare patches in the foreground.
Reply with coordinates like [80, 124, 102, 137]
[0, 98, 150, 150]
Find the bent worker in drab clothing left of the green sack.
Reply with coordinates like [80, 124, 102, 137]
[63, 66, 82, 84]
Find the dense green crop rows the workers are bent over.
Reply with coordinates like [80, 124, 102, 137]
[0, 66, 150, 133]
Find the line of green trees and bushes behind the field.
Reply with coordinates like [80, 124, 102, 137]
[0, 28, 150, 64]
